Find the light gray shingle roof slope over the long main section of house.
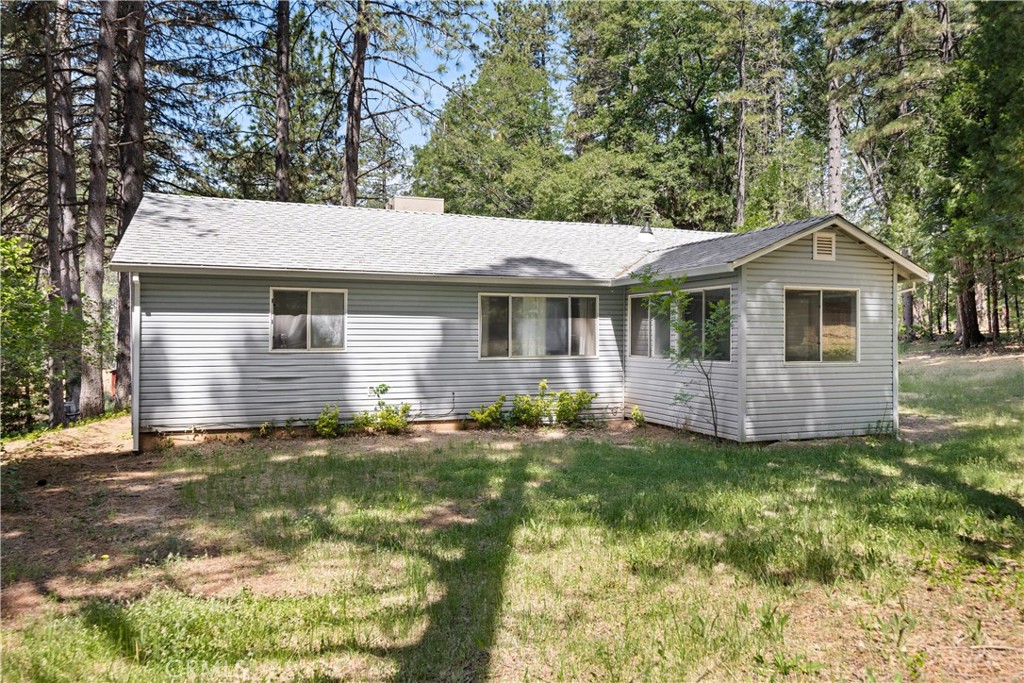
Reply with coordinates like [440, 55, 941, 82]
[112, 194, 721, 281]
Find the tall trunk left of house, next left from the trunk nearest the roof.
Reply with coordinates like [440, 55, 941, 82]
[81, 2, 118, 418]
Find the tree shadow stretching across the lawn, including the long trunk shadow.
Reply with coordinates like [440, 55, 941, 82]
[9, 419, 1024, 681]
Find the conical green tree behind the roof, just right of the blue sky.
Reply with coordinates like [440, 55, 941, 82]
[413, 2, 565, 217]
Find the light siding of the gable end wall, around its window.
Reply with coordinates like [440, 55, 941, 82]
[743, 232, 894, 440]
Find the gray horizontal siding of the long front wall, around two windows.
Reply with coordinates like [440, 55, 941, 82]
[139, 274, 625, 431]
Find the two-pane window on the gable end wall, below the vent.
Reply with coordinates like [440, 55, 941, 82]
[785, 289, 858, 362]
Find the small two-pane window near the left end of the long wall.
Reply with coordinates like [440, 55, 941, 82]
[270, 289, 347, 351]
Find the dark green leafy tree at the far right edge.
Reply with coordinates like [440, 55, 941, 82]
[926, 3, 1024, 348]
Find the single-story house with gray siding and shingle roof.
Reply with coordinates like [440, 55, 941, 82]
[112, 194, 929, 449]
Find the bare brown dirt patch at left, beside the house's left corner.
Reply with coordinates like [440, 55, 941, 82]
[0, 418, 241, 623]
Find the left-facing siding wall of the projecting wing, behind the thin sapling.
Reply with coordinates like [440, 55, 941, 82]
[623, 276, 739, 439]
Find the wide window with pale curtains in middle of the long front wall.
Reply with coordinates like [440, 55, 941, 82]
[480, 294, 597, 358]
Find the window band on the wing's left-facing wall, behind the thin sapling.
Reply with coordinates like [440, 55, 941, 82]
[630, 288, 732, 360]
